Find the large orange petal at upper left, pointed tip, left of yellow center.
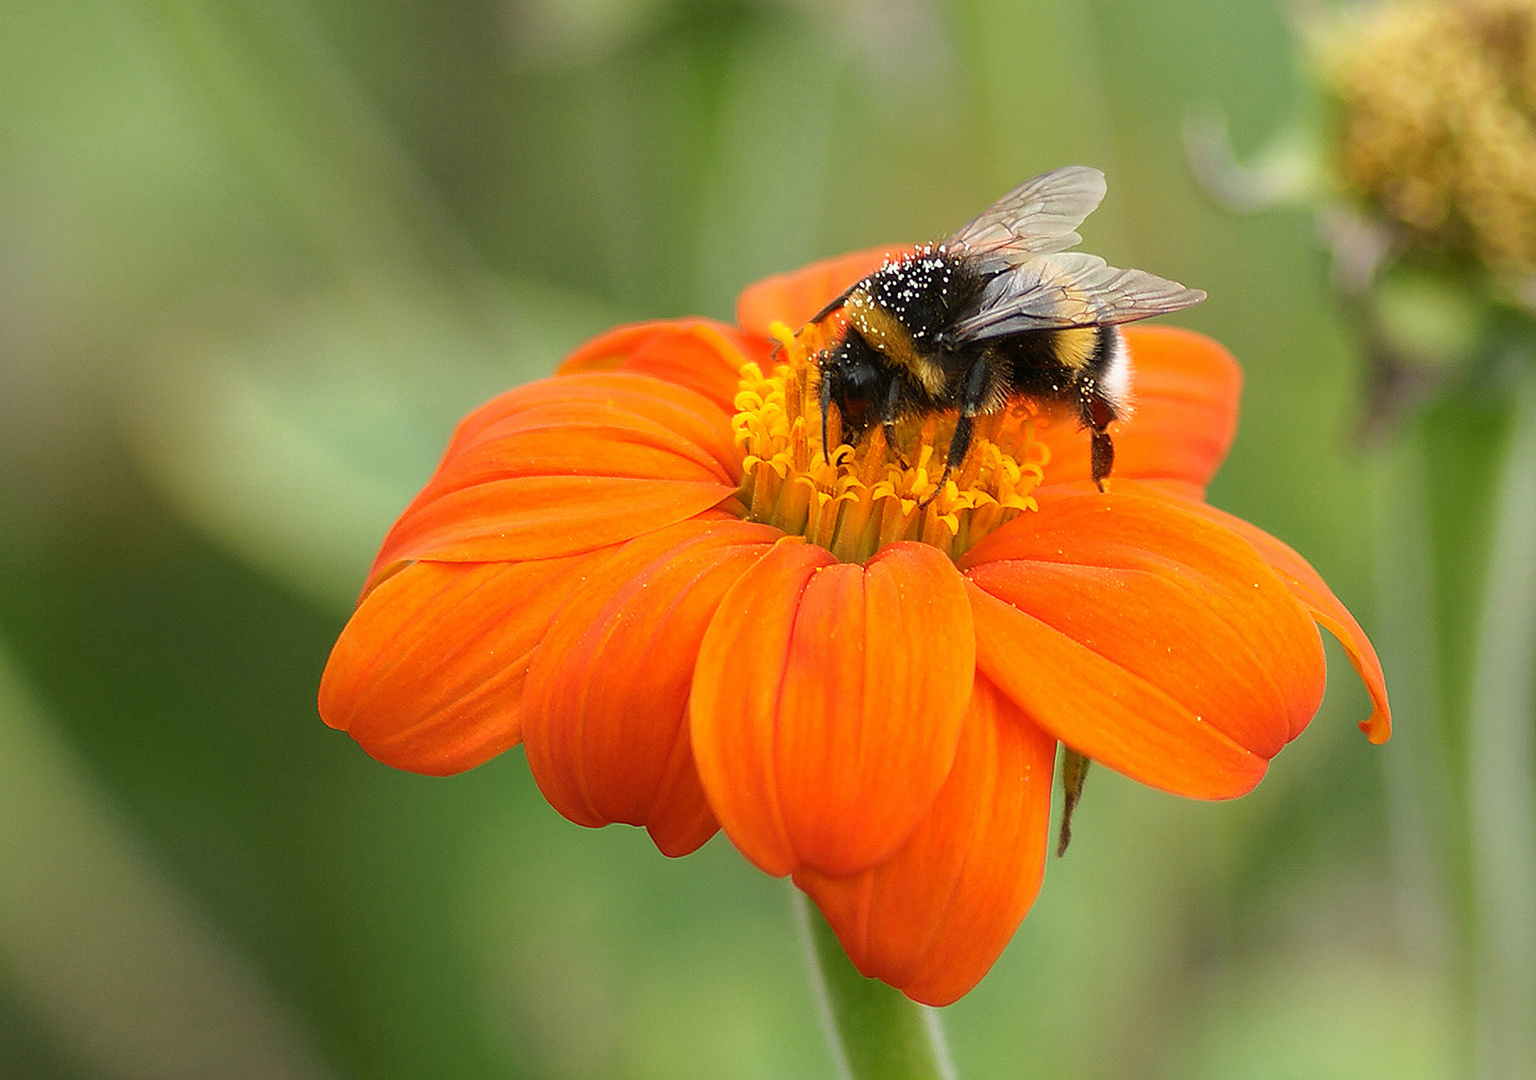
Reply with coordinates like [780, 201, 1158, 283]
[372, 373, 740, 581]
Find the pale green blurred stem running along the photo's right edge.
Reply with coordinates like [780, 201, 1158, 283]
[1467, 366, 1536, 1080]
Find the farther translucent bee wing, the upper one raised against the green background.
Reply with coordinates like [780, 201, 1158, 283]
[945, 164, 1104, 264]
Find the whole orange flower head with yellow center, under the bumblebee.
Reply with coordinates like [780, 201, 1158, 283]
[319, 252, 1390, 1005]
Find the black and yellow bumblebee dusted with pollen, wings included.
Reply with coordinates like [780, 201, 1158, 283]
[811, 166, 1206, 499]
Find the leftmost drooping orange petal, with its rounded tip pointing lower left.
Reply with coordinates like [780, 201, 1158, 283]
[319, 556, 591, 776]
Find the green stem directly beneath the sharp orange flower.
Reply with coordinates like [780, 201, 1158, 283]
[794, 890, 954, 1080]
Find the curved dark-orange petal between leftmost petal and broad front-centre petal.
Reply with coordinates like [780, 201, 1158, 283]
[522, 521, 782, 856]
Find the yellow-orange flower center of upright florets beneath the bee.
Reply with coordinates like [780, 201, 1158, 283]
[731, 323, 1051, 562]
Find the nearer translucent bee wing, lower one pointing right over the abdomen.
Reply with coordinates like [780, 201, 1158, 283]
[948, 252, 1206, 343]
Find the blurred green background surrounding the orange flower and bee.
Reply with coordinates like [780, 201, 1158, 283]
[0, 0, 1437, 1080]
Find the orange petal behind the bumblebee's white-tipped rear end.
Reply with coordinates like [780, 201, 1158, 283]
[1037, 326, 1243, 490]
